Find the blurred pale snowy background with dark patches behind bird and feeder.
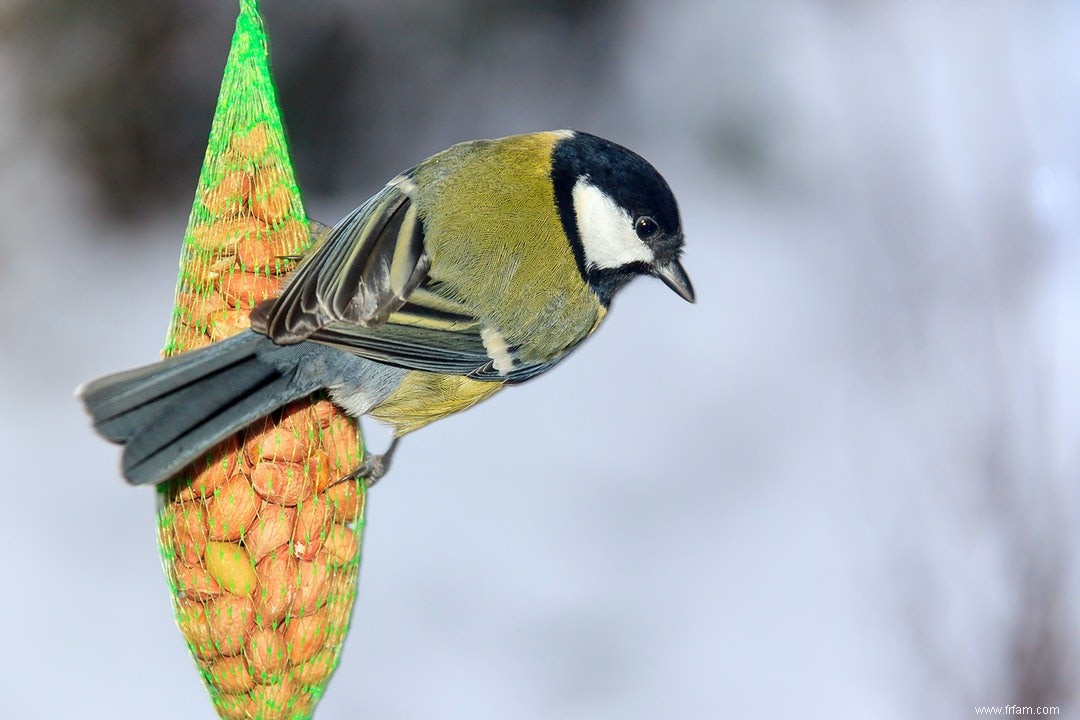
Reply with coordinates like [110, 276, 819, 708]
[0, 0, 1080, 720]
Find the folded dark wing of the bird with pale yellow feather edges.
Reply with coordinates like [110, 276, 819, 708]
[252, 182, 558, 382]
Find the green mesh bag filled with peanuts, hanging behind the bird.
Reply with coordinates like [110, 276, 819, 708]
[158, 0, 366, 720]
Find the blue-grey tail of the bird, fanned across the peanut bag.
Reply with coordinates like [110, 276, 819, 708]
[77, 331, 318, 485]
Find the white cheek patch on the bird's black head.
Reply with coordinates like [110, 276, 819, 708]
[572, 178, 656, 270]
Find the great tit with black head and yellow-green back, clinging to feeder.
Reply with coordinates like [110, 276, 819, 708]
[78, 131, 693, 485]
